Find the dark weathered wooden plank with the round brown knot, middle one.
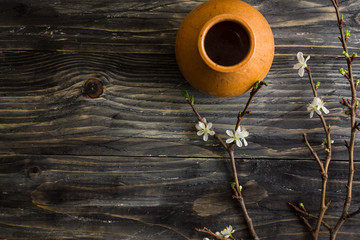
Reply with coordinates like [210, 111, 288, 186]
[0, 52, 359, 159]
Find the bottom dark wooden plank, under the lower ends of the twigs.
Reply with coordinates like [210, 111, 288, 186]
[0, 155, 360, 240]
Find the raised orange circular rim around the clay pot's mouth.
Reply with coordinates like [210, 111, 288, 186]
[198, 14, 255, 72]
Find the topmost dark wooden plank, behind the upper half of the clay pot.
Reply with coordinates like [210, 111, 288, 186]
[0, 0, 360, 54]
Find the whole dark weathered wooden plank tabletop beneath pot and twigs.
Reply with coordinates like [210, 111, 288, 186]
[0, 0, 360, 240]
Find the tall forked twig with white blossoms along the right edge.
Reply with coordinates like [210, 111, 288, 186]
[288, 0, 360, 240]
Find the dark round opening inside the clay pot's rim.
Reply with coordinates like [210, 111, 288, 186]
[204, 20, 251, 67]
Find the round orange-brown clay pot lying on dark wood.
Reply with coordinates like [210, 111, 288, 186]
[175, 0, 274, 97]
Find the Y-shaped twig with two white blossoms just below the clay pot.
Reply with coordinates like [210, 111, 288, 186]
[181, 81, 267, 240]
